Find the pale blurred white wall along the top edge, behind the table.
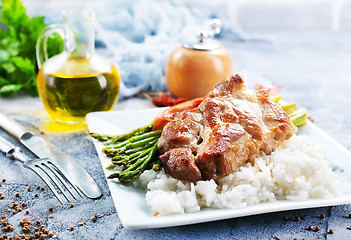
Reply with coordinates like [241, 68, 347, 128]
[23, 0, 351, 31]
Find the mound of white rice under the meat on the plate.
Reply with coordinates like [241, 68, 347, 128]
[135, 136, 351, 215]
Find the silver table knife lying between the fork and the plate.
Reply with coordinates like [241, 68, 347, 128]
[0, 111, 102, 199]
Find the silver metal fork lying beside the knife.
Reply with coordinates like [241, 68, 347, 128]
[0, 136, 83, 204]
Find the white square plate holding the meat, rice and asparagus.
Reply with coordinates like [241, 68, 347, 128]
[87, 108, 351, 229]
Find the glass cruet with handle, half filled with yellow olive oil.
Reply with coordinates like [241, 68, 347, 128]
[36, 9, 120, 123]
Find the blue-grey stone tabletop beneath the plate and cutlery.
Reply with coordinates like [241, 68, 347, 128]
[0, 23, 351, 239]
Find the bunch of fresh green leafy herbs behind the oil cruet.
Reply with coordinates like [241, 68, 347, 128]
[0, 0, 63, 97]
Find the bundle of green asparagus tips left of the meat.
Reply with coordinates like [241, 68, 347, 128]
[90, 124, 162, 183]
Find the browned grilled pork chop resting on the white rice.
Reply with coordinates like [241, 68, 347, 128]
[158, 75, 297, 181]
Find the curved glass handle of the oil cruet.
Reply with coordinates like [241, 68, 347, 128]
[36, 24, 64, 69]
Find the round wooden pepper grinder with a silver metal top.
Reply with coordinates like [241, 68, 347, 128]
[166, 19, 233, 99]
